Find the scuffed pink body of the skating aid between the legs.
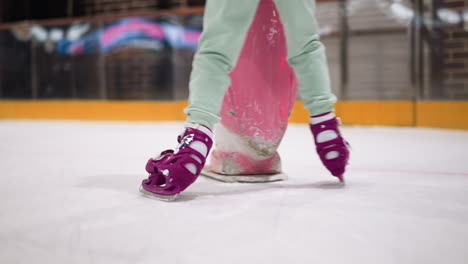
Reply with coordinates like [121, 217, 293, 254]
[211, 0, 297, 174]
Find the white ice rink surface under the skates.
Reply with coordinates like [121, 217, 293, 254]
[0, 121, 468, 264]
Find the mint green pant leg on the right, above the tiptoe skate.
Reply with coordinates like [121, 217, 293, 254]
[275, 0, 336, 115]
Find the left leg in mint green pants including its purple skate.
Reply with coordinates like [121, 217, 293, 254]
[140, 0, 259, 200]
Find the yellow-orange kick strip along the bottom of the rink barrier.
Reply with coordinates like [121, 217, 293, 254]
[0, 100, 468, 129]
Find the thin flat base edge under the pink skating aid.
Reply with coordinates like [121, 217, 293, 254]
[201, 169, 288, 183]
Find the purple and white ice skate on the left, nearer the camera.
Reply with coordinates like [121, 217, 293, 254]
[140, 123, 213, 201]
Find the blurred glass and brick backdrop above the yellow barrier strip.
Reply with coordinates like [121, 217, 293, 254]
[0, 0, 468, 100]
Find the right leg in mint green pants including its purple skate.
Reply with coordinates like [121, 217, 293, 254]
[275, 0, 349, 181]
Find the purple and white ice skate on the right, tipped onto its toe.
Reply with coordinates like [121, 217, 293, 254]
[310, 113, 349, 182]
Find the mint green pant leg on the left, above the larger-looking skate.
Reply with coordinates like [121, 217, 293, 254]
[185, 0, 259, 128]
